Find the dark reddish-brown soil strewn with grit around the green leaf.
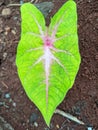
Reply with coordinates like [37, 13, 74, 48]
[0, 0, 98, 130]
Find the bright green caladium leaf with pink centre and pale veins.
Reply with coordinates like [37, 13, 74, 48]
[16, 0, 80, 126]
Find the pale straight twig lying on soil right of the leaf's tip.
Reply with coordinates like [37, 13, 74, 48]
[55, 109, 85, 125]
